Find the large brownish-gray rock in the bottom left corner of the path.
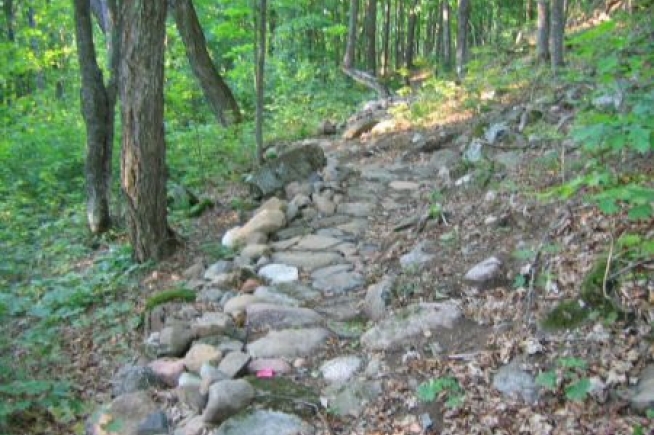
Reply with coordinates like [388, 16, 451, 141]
[86, 391, 158, 435]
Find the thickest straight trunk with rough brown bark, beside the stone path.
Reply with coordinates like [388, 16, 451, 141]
[120, 0, 176, 262]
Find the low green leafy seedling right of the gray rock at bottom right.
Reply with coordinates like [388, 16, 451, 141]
[536, 357, 591, 402]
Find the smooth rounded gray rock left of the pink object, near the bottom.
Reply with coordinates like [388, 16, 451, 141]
[202, 379, 255, 424]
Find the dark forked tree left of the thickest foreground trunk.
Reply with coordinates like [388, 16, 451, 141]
[73, 0, 119, 234]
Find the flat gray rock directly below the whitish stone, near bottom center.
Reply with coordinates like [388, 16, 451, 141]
[322, 380, 382, 417]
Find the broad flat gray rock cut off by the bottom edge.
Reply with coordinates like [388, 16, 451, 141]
[213, 409, 315, 435]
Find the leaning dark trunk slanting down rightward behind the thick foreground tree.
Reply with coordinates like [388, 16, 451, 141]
[172, 0, 242, 126]
